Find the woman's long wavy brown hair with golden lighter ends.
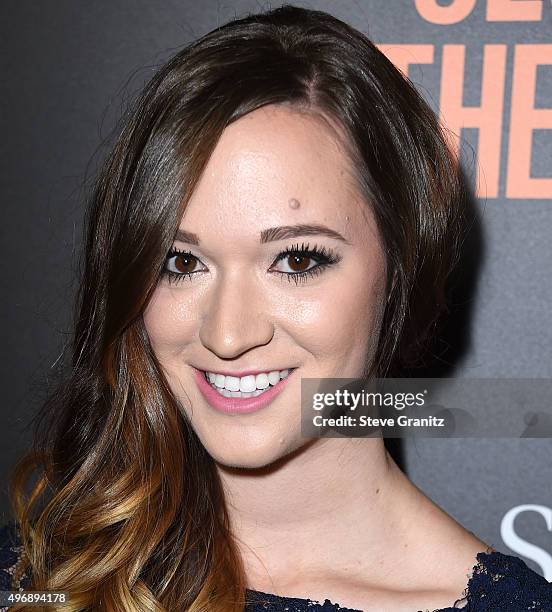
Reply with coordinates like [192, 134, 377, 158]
[11, 5, 466, 612]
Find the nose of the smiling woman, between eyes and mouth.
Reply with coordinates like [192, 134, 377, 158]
[199, 274, 274, 359]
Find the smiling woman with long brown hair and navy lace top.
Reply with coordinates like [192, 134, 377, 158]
[2, 6, 552, 612]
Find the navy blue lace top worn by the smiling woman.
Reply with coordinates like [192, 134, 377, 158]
[0, 525, 552, 612]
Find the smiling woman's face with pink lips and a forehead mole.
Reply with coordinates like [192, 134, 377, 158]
[144, 105, 386, 468]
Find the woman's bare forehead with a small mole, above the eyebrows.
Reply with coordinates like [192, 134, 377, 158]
[179, 106, 365, 237]
